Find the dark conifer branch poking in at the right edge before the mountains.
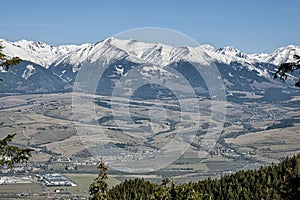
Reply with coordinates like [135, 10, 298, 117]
[274, 55, 300, 87]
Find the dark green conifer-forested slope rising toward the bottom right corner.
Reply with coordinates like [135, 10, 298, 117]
[108, 154, 300, 200]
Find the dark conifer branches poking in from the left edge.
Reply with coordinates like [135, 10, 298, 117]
[0, 45, 32, 167]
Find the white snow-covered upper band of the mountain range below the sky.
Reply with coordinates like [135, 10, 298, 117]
[0, 38, 300, 68]
